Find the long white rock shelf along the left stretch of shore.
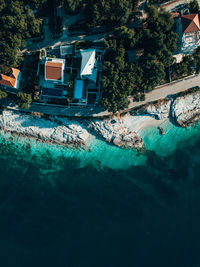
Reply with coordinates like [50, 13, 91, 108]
[0, 111, 90, 149]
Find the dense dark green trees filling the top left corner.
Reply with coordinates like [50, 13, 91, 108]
[0, 0, 47, 65]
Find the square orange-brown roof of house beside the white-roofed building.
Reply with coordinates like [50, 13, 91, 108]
[45, 61, 62, 80]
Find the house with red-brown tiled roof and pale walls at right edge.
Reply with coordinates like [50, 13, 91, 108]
[181, 14, 200, 52]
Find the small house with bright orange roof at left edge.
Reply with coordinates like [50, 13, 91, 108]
[0, 68, 21, 92]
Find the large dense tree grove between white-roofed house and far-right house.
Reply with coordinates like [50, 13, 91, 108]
[101, 6, 178, 112]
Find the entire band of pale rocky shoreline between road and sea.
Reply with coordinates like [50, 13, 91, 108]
[0, 90, 200, 151]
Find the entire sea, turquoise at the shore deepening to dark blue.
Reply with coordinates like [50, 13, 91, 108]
[0, 124, 200, 267]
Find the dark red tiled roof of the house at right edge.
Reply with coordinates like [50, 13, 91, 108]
[181, 14, 200, 33]
